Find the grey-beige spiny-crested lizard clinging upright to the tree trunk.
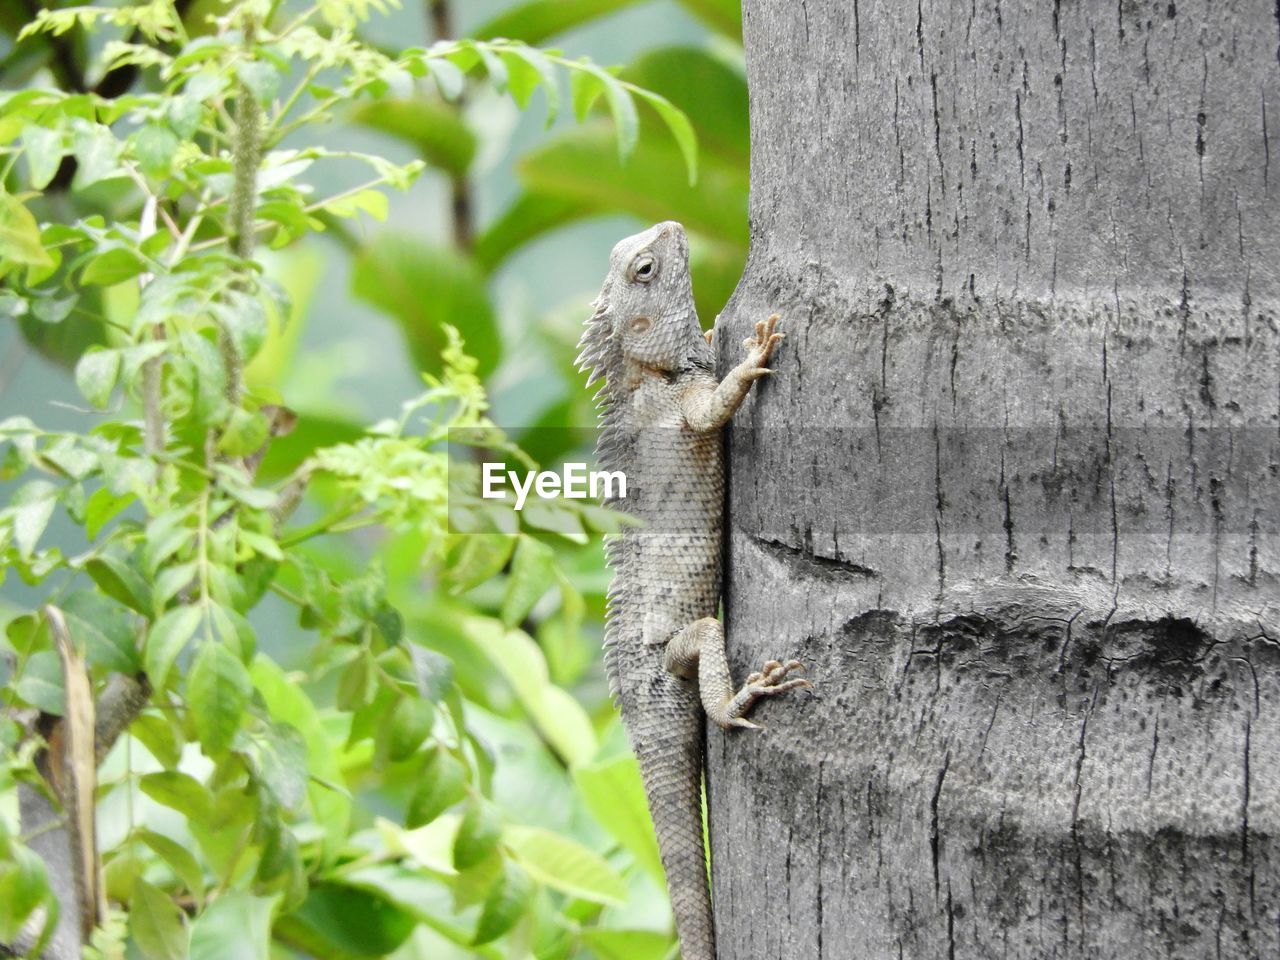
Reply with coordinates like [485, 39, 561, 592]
[577, 221, 808, 960]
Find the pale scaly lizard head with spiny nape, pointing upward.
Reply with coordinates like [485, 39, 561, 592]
[579, 220, 710, 385]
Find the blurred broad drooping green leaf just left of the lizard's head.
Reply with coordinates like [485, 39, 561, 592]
[352, 233, 502, 376]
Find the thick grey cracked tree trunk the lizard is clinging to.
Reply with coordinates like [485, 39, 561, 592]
[709, 0, 1280, 960]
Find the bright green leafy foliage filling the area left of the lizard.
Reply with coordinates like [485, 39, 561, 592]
[0, 0, 746, 959]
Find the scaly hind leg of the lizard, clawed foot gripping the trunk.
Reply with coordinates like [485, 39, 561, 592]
[666, 617, 809, 730]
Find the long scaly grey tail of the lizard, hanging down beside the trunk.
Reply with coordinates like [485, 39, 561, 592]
[634, 675, 716, 960]
